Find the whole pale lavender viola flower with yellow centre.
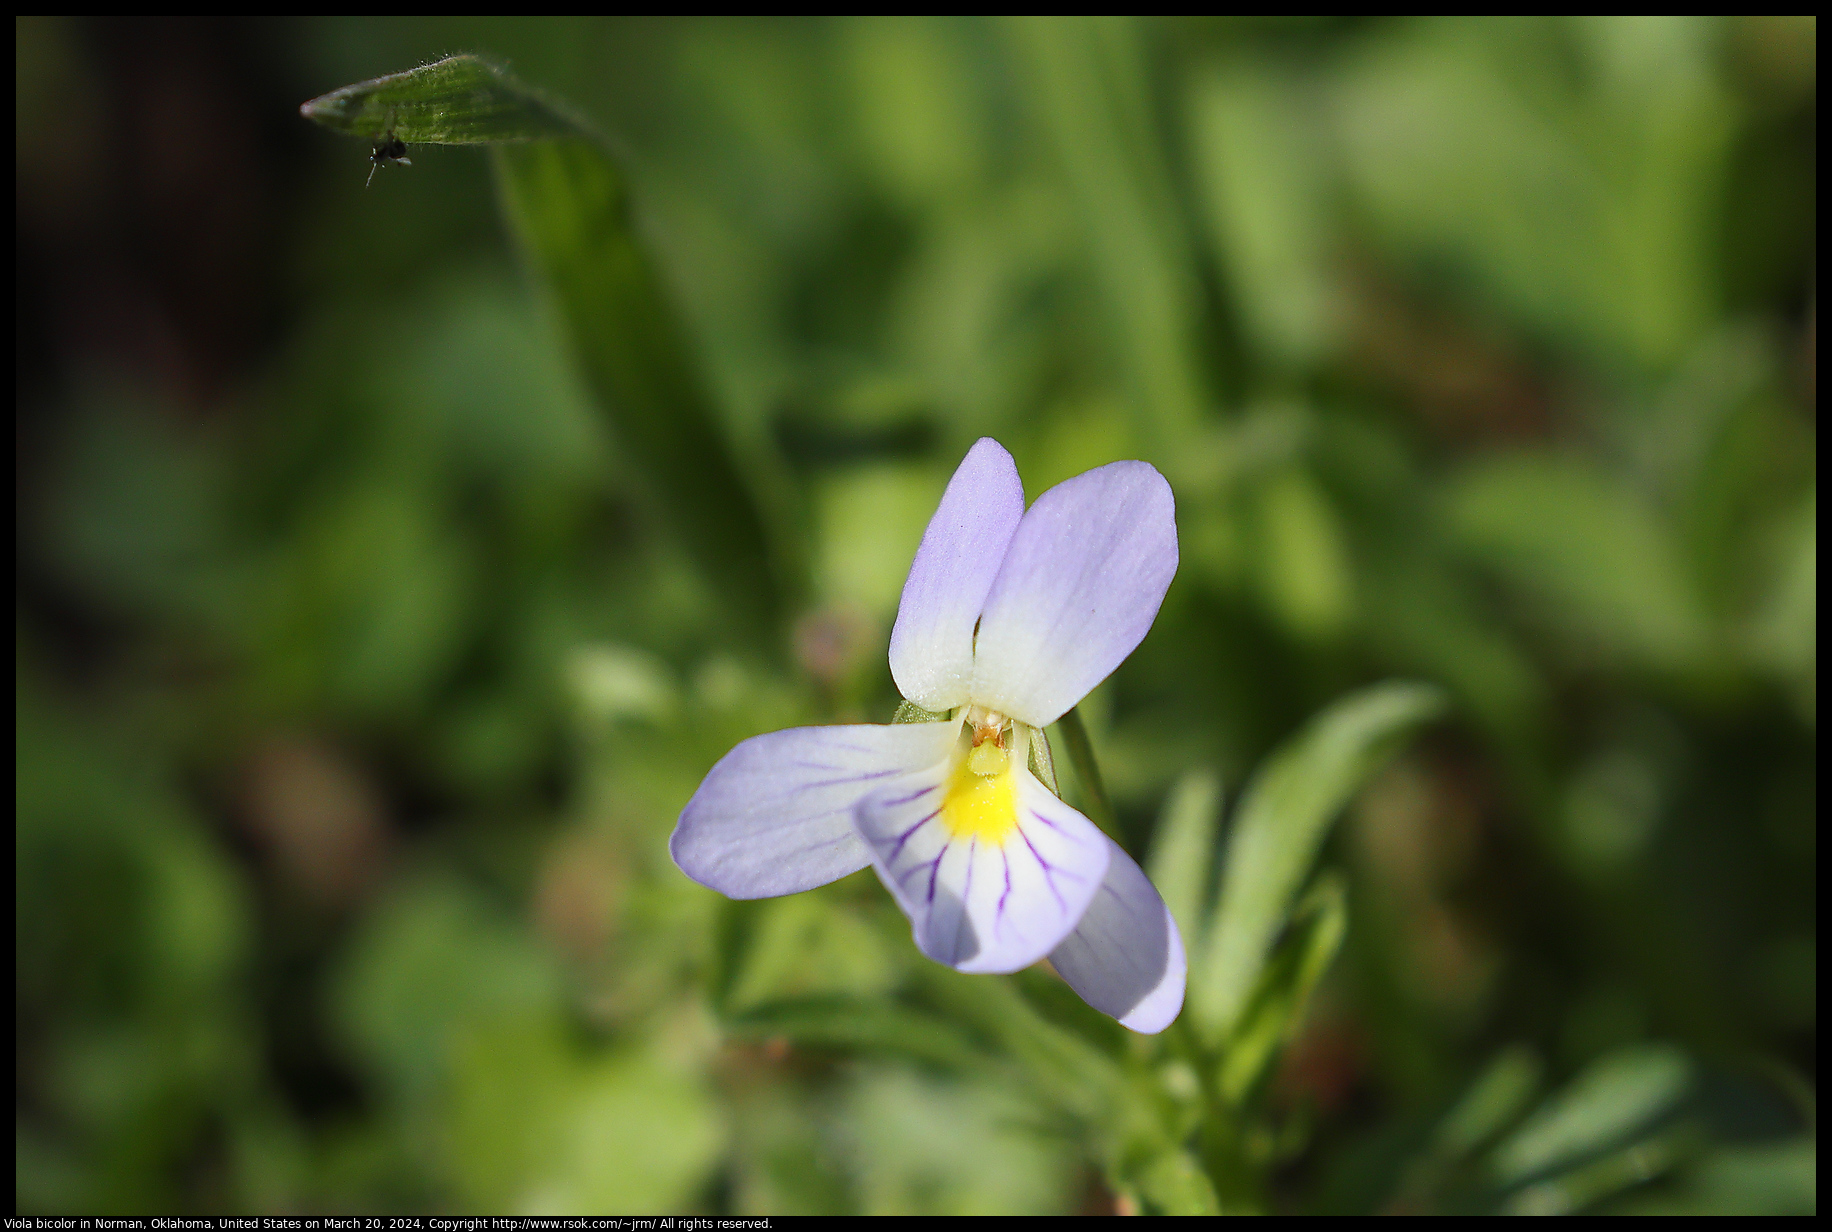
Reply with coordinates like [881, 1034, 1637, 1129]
[669, 438, 1183, 1034]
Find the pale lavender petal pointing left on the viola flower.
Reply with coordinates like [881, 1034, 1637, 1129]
[669, 722, 960, 898]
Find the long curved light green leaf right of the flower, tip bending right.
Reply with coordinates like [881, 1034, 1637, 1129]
[1189, 682, 1444, 1040]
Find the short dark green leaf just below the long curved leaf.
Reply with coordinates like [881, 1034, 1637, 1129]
[1220, 876, 1348, 1104]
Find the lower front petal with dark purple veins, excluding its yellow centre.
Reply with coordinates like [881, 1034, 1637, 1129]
[857, 766, 1108, 972]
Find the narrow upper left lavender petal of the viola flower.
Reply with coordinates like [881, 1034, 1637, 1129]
[890, 436, 1024, 711]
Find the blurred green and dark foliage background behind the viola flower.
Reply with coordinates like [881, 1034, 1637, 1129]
[15, 17, 1817, 1214]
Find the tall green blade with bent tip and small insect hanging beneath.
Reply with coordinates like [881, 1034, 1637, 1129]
[300, 55, 782, 638]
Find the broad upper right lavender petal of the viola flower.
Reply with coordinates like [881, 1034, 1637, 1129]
[969, 462, 1176, 728]
